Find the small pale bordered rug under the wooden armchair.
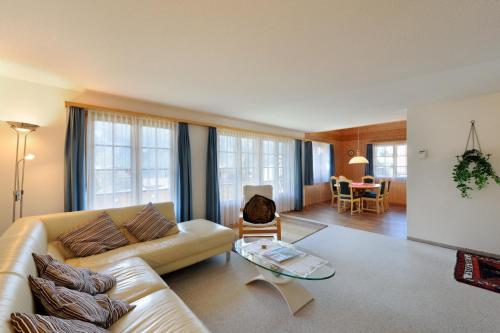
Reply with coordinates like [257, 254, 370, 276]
[229, 216, 326, 243]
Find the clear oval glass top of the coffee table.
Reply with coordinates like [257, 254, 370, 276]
[234, 239, 335, 280]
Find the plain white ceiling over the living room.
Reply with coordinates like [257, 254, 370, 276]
[0, 0, 500, 131]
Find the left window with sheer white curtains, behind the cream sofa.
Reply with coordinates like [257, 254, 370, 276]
[86, 110, 177, 209]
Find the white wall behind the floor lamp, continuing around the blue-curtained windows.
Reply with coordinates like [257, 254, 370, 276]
[0, 76, 304, 233]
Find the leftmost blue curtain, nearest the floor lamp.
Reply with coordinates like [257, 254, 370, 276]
[64, 106, 86, 212]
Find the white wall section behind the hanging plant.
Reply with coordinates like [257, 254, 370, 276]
[407, 93, 500, 254]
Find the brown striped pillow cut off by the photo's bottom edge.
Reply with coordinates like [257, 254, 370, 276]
[10, 312, 109, 333]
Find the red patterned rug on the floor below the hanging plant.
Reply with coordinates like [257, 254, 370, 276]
[455, 251, 500, 293]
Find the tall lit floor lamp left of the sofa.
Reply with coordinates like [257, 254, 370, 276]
[7, 121, 38, 222]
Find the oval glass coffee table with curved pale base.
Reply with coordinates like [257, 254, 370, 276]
[234, 239, 335, 315]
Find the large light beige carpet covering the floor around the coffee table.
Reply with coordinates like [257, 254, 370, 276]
[166, 226, 500, 333]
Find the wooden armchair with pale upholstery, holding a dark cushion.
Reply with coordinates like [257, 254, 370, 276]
[238, 185, 281, 240]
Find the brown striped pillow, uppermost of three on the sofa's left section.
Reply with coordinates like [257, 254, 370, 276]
[32, 253, 116, 295]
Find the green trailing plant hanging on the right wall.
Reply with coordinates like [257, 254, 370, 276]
[453, 120, 500, 198]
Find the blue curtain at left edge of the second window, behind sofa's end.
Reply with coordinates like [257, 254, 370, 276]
[205, 127, 220, 224]
